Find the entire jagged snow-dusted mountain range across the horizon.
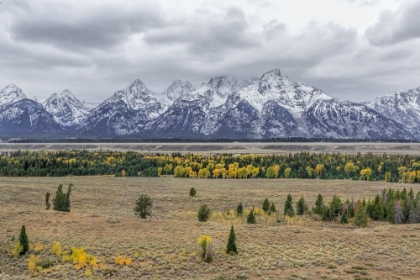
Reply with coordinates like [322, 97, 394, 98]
[0, 69, 420, 140]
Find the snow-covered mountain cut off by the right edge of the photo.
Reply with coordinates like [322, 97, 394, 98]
[366, 87, 420, 136]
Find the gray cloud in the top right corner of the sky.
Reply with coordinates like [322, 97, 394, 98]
[366, 1, 420, 46]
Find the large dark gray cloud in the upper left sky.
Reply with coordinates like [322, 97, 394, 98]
[10, 1, 163, 50]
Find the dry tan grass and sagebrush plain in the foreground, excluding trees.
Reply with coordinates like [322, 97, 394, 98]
[0, 176, 420, 279]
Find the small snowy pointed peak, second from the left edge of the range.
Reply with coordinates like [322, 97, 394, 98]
[42, 89, 94, 127]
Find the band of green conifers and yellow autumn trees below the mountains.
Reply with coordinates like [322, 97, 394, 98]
[0, 150, 420, 183]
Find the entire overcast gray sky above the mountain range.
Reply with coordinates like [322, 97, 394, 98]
[0, 0, 420, 102]
